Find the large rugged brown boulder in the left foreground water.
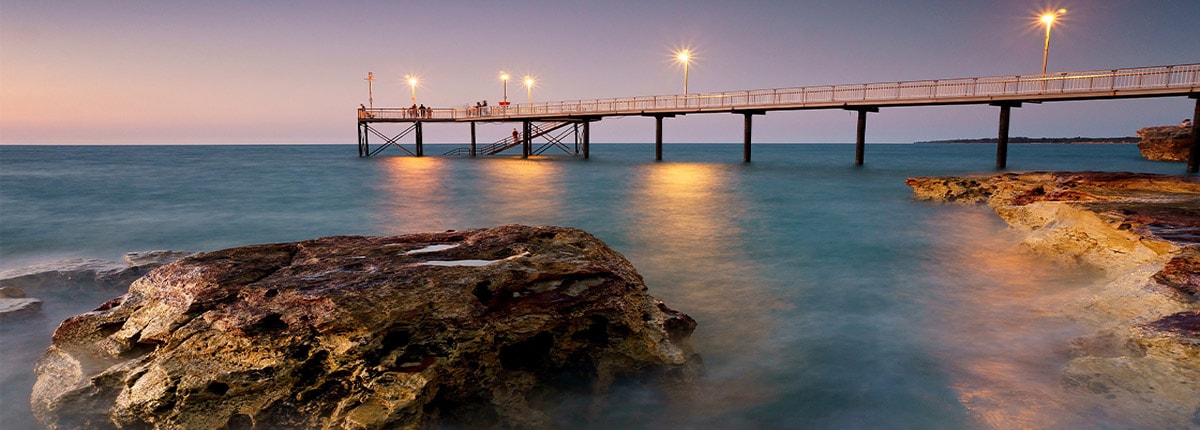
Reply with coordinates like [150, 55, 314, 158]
[32, 226, 700, 429]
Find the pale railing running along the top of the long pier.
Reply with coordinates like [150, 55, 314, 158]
[359, 64, 1200, 121]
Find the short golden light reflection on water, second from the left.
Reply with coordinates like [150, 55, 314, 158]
[480, 159, 565, 225]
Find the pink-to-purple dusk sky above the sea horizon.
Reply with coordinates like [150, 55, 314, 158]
[0, 0, 1200, 144]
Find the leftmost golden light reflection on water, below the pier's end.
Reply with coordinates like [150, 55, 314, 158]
[379, 156, 462, 234]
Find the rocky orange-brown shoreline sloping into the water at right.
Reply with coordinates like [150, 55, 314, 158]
[907, 172, 1200, 428]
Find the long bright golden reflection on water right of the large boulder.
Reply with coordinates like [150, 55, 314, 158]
[625, 163, 794, 417]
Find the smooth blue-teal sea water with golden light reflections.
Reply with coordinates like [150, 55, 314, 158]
[0, 144, 1184, 429]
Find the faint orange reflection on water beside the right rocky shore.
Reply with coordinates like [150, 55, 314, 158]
[926, 208, 1096, 429]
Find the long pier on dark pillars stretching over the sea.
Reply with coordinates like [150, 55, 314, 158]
[358, 64, 1200, 173]
